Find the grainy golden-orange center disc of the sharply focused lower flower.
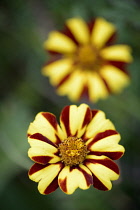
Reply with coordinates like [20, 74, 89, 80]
[59, 137, 88, 166]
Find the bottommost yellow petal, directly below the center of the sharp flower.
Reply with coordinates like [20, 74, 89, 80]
[58, 165, 93, 194]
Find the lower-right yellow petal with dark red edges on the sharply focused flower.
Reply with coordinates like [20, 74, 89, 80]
[86, 155, 119, 190]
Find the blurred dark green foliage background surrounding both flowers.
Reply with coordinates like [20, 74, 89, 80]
[0, 0, 140, 210]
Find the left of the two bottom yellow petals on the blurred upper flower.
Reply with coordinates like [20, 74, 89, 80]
[57, 69, 86, 101]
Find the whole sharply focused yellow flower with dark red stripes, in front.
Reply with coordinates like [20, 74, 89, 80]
[28, 104, 124, 194]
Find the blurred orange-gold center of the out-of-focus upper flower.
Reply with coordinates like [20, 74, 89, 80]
[76, 45, 102, 71]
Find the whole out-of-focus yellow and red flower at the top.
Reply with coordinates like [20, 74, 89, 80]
[42, 18, 132, 102]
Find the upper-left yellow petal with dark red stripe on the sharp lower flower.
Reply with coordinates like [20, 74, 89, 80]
[28, 112, 65, 143]
